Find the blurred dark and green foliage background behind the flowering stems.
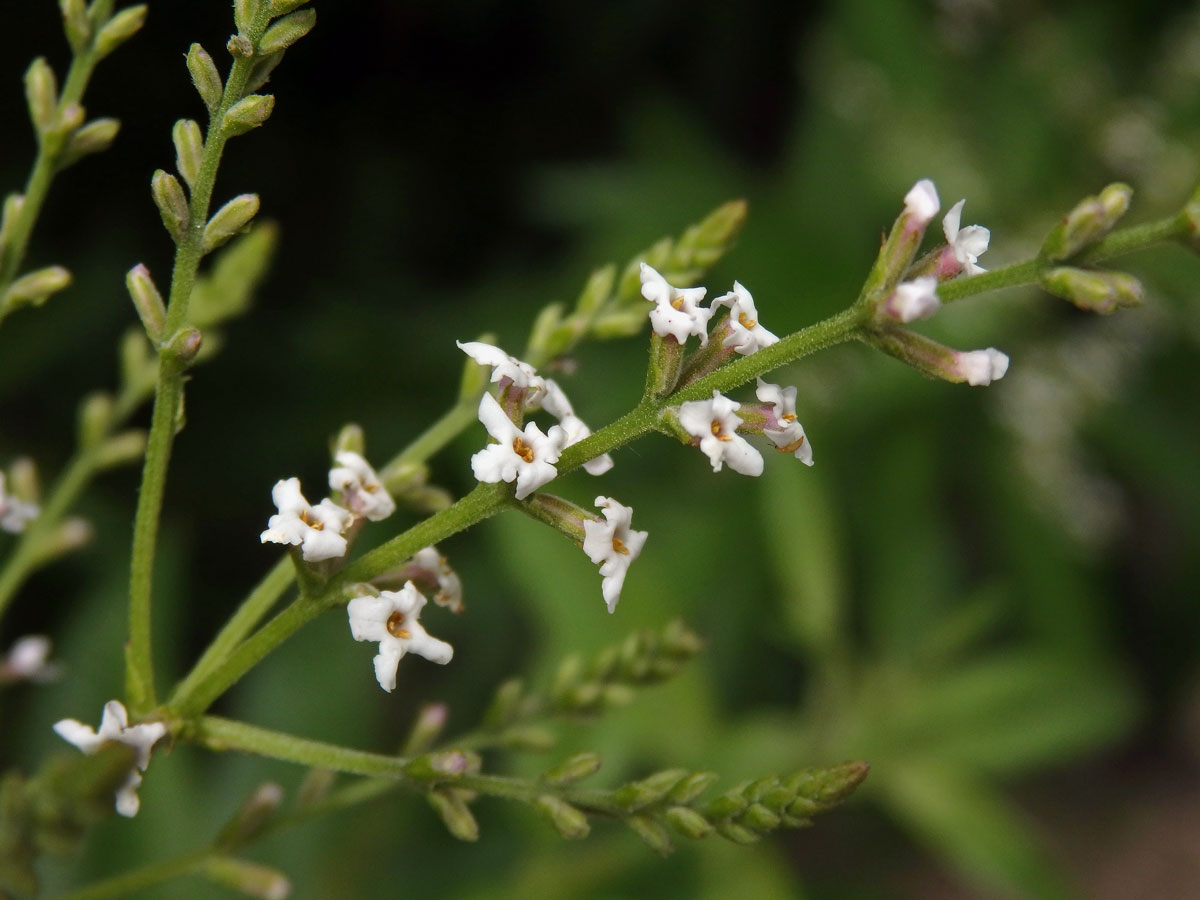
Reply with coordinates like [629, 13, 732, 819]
[0, 0, 1200, 900]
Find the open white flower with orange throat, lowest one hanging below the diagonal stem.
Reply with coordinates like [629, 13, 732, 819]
[346, 581, 454, 692]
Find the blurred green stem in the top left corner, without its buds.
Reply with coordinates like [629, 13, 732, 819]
[0, 0, 115, 322]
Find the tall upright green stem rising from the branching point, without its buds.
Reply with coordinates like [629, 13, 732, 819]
[125, 4, 270, 716]
